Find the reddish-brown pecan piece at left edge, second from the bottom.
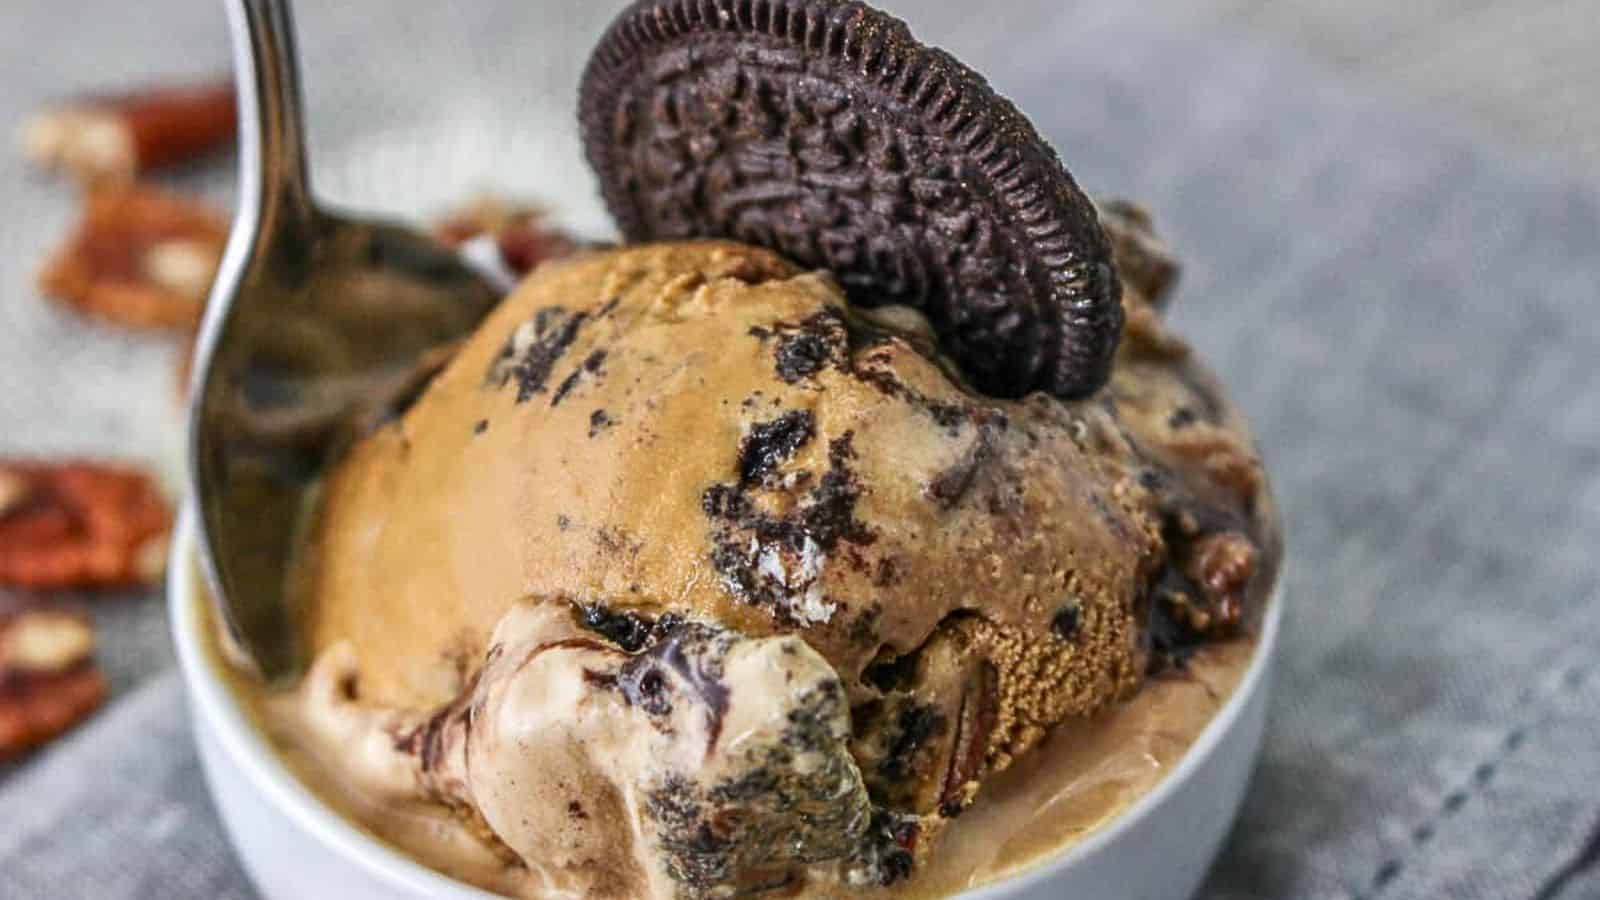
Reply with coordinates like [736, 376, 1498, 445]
[0, 463, 171, 589]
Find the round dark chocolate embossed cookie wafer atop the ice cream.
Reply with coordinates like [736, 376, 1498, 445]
[579, 0, 1122, 397]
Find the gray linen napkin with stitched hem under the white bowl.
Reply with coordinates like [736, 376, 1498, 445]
[0, 0, 1600, 900]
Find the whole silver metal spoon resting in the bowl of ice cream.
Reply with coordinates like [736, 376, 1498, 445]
[189, 0, 499, 681]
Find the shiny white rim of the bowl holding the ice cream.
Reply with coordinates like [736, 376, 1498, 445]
[166, 503, 1283, 900]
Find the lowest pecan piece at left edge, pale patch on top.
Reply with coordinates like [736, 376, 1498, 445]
[0, 607, 106, 759]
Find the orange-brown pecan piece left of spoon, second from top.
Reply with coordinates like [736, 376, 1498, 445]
[38, 186, 227, 330]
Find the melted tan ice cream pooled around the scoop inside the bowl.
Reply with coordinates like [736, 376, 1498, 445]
[197, 578, 1254, 900]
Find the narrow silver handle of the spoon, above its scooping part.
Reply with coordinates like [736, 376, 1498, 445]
[226, 0, 317, 235]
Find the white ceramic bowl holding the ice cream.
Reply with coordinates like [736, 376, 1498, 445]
[168, 512, 1283, 900]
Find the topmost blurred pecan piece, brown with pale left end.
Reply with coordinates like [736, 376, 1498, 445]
[22, 78, 237, 183]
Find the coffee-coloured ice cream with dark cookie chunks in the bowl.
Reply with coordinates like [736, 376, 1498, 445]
[246, 205, 1277, 897]
